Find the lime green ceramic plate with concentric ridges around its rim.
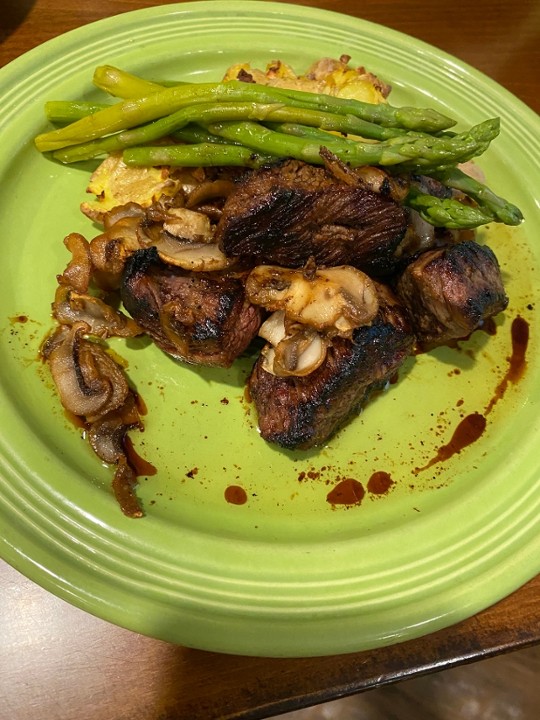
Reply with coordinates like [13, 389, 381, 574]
[0, 0, 540, 656]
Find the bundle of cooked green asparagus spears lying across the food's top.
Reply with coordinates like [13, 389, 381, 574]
[35, 65, 522, 228]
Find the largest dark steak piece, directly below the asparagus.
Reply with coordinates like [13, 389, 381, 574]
[215, 160, 408, 276]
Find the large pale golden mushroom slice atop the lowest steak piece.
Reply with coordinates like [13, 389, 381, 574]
[246, 265, 379, 336]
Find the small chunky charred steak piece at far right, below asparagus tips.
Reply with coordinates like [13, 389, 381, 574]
[397, 241, 508, 347]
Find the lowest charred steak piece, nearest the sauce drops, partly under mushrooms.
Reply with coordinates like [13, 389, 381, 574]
[248, 285, 414, 449]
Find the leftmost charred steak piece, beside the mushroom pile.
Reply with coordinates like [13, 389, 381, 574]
[121, 248, 261, 367]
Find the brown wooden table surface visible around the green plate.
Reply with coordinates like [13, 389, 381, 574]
[0, 0, 540, 720]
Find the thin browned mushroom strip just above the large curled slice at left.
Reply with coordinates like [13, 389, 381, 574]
[52, 285, 143, 338]
